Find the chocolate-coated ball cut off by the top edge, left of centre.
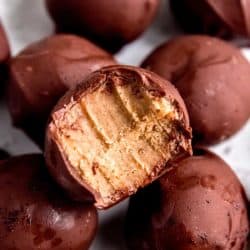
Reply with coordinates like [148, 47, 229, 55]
[46, 0, 160, 52]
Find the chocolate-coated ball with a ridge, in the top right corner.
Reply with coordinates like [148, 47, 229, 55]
[170, 0, 250, 38]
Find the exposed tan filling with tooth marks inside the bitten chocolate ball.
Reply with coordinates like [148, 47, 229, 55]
[51, 83, 187, 207]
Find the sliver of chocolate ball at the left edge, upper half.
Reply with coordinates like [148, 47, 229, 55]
[0, 22, 10, 91]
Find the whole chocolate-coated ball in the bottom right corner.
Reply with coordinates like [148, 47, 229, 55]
[125, 150, 249, 250]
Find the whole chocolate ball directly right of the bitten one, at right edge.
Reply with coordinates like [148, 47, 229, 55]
[143, 36, 250, 144]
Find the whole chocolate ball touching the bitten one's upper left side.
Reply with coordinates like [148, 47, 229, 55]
[8, 35, 115, 146]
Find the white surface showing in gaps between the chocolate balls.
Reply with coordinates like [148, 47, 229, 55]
[0, 0, 250, 250]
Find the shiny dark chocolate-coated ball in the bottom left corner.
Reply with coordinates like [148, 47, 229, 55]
[0, 155, 97, 250]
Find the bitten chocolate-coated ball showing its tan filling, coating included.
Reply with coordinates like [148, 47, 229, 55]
[45, 65, 191, 208]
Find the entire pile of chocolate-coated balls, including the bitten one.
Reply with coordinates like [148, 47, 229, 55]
[0, 0, 250, 250]
